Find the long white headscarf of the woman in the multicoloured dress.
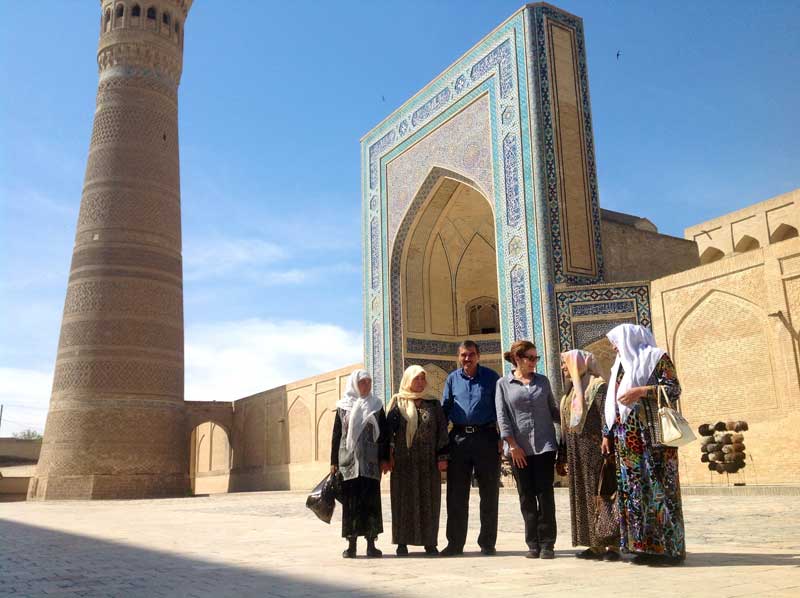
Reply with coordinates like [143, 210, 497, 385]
[605, 324, 666, 429]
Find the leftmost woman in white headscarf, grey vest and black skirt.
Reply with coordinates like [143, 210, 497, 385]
[331, 370, 389, 559]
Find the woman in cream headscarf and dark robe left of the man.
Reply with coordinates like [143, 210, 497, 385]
[387, 365, 449, 556]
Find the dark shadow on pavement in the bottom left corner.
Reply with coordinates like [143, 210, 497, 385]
[0, 520, 369, 598]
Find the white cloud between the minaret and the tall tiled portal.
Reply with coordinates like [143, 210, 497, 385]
[185, 318, 363, 401]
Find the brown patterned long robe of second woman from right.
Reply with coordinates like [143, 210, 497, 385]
[562, 379, 607, 548]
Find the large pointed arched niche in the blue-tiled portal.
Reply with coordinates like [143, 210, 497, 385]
[390, 167, 502, 388]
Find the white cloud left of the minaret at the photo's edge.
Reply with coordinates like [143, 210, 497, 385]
[0, 368, 53, 436]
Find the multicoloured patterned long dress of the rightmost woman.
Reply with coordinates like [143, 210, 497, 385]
[612, 354, 686, 559]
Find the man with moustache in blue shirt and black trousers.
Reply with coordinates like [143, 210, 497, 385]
[441, 340, 500, 556]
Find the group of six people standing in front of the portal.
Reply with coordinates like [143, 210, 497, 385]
[331, 324, 686, 565]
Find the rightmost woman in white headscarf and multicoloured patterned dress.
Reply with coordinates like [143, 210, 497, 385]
[603, 324, 686, 565]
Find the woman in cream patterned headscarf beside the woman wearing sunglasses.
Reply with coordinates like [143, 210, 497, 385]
[556, 350, 620, 561]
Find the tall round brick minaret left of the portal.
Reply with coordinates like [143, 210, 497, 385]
[28, 0, 192, 499]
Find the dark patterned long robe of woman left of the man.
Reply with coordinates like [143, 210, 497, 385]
[387, 400, 449, 546]
